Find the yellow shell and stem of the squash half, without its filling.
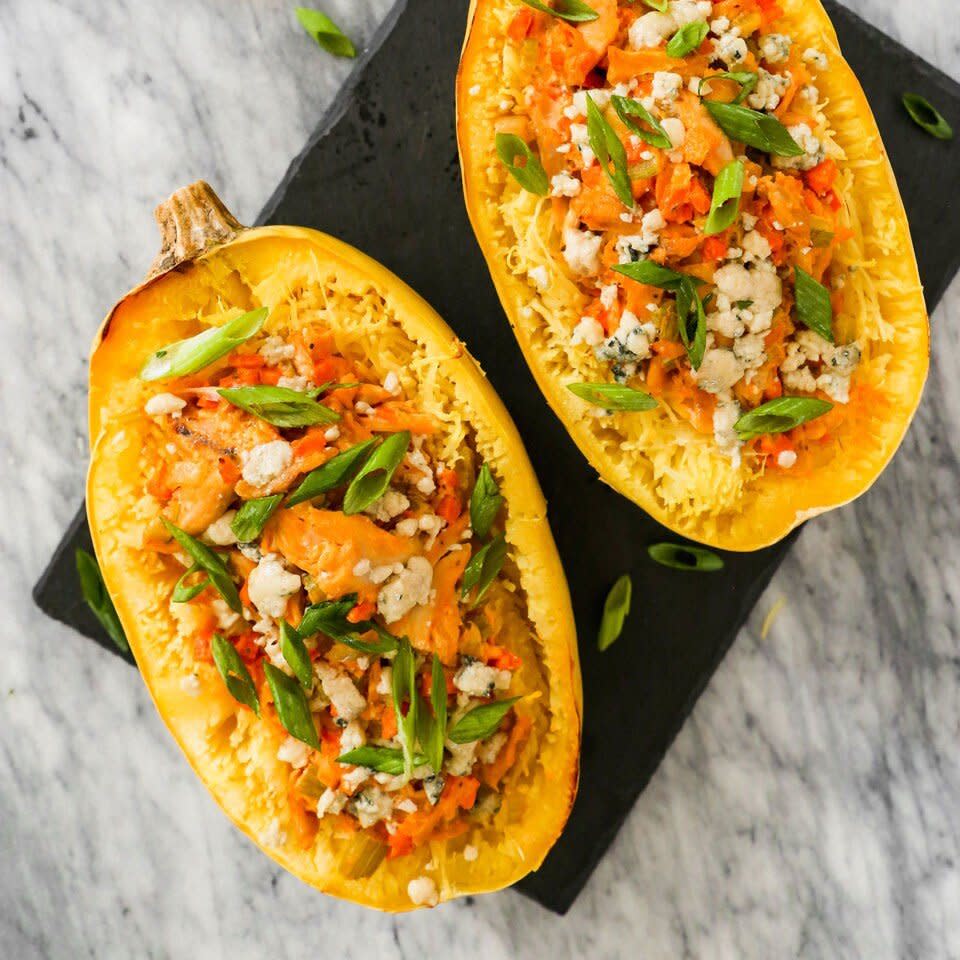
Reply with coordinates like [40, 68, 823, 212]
[87, 183, 581, 911]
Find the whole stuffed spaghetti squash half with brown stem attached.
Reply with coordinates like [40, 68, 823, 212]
[87, 183, 580, 910]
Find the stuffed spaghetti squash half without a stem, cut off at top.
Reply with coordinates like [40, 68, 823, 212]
[457, 0, 929, 550]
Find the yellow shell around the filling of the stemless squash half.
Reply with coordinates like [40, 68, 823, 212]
[457, 0, 929, 551]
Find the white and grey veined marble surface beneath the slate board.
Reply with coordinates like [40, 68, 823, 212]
[0, 0, 960, 960]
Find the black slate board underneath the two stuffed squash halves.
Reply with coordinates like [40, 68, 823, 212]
[34, 0, 960, 912]
